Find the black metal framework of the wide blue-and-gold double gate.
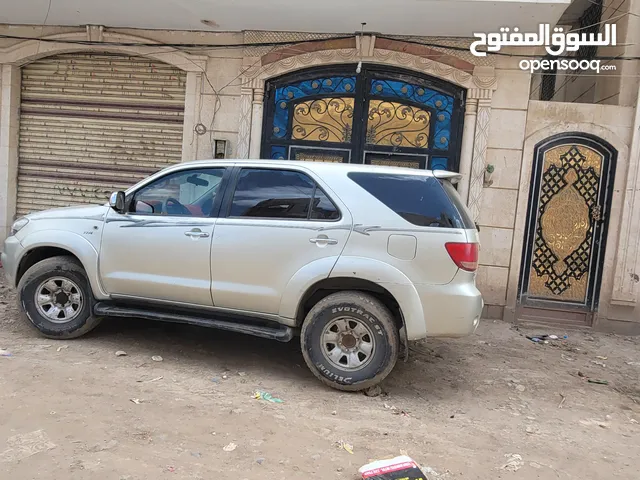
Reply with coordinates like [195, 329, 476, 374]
[261, 64, 466, 172]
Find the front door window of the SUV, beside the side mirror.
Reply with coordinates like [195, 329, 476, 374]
[130, 168, 224, 217]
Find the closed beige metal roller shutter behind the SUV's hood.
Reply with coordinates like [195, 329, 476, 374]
[17, 54, 186, 215]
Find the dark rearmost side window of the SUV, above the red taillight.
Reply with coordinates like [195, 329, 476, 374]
[348, 172, 475, 228]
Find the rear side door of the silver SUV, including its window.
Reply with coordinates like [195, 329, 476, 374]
[211, 166, 352, 314]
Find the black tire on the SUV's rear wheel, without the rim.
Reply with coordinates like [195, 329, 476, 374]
[300, 292, 400, 392]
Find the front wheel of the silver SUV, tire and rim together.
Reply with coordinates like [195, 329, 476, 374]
[18, 256, 101, 339]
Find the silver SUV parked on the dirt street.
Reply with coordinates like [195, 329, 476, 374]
[2, 160, 483, 390]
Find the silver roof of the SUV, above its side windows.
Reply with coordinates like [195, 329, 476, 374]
[170, 159, 459, 178]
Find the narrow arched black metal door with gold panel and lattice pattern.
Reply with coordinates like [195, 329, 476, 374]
[520, 134, 616, 323]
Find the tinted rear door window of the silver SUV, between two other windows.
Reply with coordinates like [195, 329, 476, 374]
[229, 168, 340, 220]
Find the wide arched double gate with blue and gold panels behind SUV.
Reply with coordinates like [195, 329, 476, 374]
[262, 65, 464, 171]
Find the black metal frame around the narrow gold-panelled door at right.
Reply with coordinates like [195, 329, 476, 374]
[518, 132, 618, 313]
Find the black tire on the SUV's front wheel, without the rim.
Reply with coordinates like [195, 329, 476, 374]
[18, 256, 102, 340]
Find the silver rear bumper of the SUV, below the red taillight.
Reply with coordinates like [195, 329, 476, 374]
[410, 274, 484, 340]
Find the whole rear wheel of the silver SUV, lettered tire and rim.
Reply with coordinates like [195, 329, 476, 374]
[300, 292, 400, 391]
